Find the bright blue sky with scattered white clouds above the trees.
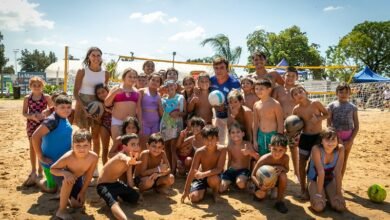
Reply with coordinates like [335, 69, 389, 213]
[0, 0, 390, 69]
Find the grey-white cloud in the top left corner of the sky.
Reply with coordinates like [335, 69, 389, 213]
[0, 0, 54, 31]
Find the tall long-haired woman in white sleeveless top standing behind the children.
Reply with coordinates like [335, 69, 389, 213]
[73, 47, 110, 168]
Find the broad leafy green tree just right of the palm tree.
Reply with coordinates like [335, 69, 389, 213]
[247, 25, 324, 79]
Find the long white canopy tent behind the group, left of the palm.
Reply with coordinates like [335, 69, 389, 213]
[45, 60, 213, 80]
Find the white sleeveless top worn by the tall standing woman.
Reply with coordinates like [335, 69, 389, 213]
[80, 67, 106, 95]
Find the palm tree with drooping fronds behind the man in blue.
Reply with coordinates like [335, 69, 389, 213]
[200, 34, 242, 64]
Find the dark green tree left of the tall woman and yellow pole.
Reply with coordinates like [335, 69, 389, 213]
[18, 49, 57, 72]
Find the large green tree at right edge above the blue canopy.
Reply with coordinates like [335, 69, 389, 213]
[338, 21, 390, 76]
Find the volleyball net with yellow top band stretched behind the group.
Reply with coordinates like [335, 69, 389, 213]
[59, 48, 390, 111]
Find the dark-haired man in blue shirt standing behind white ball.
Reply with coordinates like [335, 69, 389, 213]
[210, 57, 241, 144]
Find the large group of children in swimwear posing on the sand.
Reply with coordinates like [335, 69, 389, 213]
[23, 53, 359, 219]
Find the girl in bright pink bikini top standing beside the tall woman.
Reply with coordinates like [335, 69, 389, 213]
[104, 68, 142, 141]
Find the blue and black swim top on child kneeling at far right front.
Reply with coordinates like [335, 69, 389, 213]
[307, 145, 339, 184]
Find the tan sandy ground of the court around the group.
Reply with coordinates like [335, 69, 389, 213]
[0, 100, 390, 220]
